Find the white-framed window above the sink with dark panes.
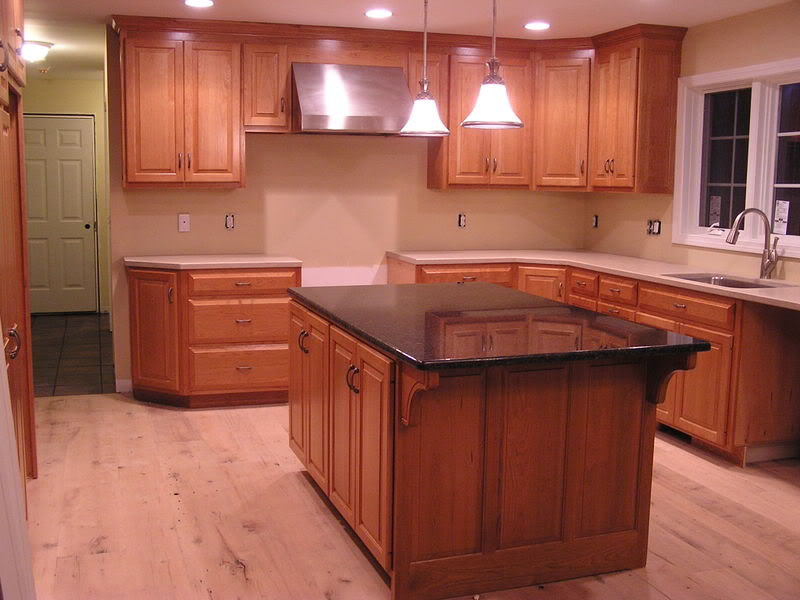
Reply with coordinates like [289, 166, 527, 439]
[673, 58, 800, 257]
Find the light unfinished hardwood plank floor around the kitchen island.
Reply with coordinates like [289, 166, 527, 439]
[28, 394, 800, 600]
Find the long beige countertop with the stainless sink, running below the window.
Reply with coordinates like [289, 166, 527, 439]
[386, 250, 800, 310]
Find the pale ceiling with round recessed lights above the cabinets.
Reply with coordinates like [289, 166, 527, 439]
[25, 0, 786, 78]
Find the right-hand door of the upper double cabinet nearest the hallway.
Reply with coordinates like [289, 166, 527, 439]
[184, 42, 242, 183]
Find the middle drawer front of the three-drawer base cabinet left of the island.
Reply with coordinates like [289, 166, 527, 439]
[188, 298, 289, 344]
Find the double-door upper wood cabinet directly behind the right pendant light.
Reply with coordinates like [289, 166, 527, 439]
[447, 55, 531, 186]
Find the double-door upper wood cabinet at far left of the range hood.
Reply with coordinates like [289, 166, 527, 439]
[123, 37, 244, 186]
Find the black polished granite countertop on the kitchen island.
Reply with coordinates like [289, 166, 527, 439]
[289, 283, 710, 370]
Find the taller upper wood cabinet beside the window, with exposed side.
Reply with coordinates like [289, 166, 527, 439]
[589, 25, 685, 193]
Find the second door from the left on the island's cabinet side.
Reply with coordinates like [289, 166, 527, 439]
[303, 312, 330, 494]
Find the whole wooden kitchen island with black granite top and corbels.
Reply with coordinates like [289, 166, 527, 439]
[289, 283, 710, 600]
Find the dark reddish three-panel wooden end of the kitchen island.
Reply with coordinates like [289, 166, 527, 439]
[393, 361, 655, 600]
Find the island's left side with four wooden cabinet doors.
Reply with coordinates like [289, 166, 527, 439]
[289, 302, 395, 570]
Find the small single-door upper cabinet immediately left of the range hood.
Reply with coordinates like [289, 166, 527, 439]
[242, 44, 291, 132]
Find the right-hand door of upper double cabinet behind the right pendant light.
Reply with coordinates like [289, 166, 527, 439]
[491, 59, 531, 185]
